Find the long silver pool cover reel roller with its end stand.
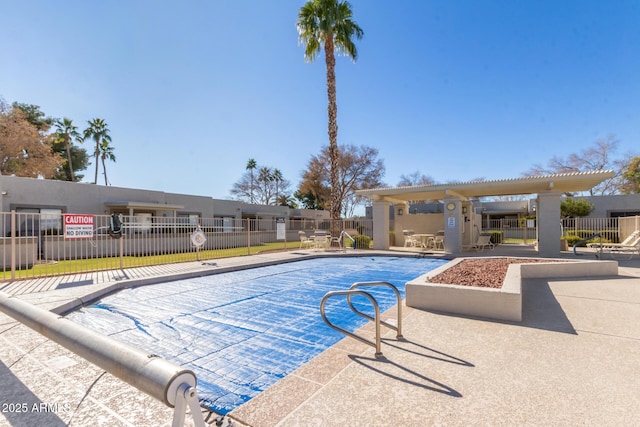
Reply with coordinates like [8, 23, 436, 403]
[0, 292, 205, 427]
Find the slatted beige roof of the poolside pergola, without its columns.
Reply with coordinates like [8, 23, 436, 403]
[356, 170, 615, 203]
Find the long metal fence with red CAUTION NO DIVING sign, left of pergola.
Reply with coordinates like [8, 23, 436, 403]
[0, 212, 373, 281]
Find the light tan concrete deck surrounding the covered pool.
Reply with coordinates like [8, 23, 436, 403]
[0, 245, 640, 427]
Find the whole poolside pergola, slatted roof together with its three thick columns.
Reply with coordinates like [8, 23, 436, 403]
[356, 170, 615, 256]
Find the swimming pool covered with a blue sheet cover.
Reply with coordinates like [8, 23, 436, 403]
[68, 257, 447, 414]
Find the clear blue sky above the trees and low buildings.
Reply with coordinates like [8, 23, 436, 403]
[0, 0, 640, 198]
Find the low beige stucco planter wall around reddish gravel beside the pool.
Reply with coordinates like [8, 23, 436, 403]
[405, 258, 618, 322]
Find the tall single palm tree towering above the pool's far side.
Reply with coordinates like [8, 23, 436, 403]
[297, 0, 364, 227]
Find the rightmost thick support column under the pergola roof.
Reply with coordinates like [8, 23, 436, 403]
[536, 193, 562, 257]
